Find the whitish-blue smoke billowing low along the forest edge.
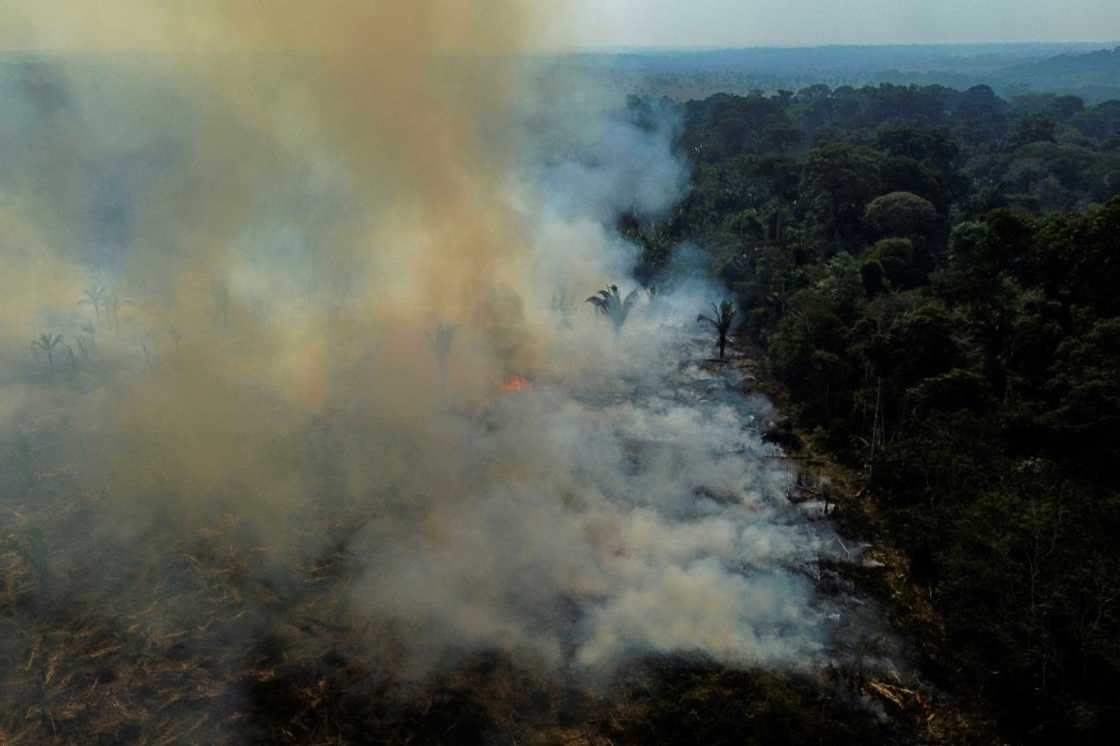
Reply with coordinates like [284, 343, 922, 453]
[340, 82, 842, 672]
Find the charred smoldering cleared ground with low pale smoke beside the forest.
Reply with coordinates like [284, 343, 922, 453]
[3, 309, 909, 743]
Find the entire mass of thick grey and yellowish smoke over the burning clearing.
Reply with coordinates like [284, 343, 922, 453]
[0, 23, 842, 698]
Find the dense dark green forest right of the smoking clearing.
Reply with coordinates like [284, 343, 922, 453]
[622, 85, 1120, 744]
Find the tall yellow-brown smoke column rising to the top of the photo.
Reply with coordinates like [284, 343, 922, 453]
[0, 0, 564, 521]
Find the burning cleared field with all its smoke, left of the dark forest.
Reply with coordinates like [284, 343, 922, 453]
[0, 0, 909, 744]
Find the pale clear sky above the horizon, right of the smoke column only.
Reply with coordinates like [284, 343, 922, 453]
[570, 0, 1120, 47]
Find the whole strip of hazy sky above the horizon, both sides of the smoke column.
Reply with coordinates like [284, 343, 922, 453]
[0, 0, 1120, 52]
